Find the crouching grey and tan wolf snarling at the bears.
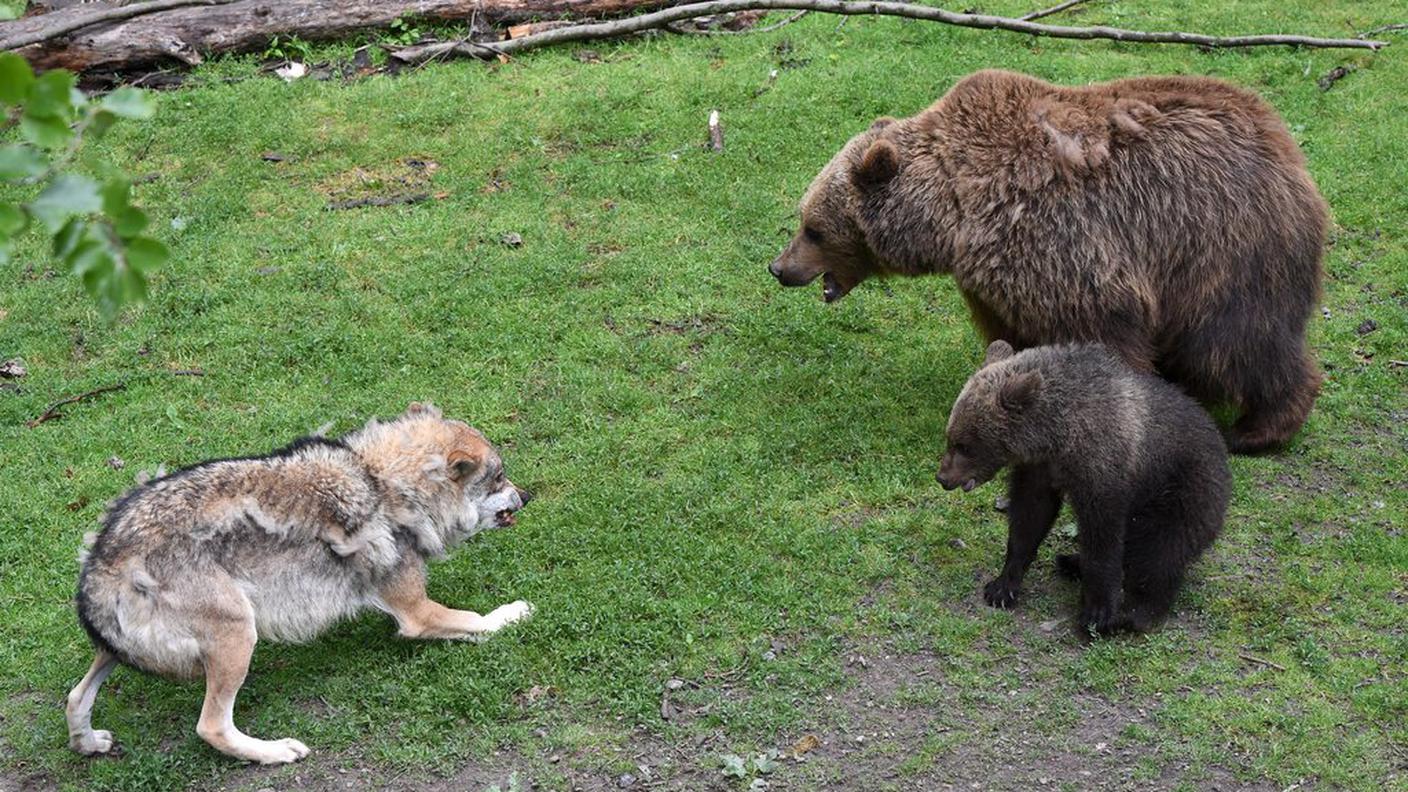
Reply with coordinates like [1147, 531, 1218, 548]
[68, 404, 532, 762]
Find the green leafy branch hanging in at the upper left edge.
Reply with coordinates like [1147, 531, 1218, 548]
[0, 52, 169, 320]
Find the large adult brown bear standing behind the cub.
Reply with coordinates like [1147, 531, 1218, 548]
[770, 70, 1328, 452]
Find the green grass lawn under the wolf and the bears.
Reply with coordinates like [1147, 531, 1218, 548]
[0, 0, 1408, 789]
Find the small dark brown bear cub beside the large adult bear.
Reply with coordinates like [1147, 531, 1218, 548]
[938, 341, 1232, 634]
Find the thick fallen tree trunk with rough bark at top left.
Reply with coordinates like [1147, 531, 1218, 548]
[0, 0, 676, 73]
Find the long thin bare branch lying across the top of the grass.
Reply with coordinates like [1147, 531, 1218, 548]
[391, 0, 1387, 63]
